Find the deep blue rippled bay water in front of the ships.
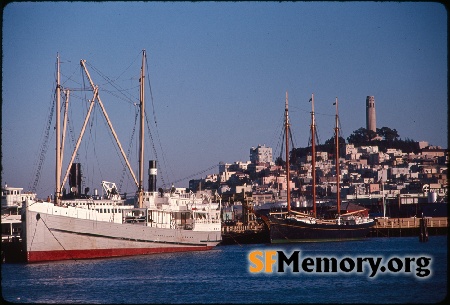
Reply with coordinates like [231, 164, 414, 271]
[2, 236, 448, 304]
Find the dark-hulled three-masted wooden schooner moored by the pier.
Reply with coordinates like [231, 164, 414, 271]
[265, 92, 375, 243]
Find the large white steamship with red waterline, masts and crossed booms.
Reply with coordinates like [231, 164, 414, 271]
[22, 50, 221, 262]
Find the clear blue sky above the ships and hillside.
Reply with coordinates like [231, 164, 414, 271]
[2, 2, 448, 196]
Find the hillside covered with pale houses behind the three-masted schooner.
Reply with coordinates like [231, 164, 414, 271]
[189, 141, 449, 221]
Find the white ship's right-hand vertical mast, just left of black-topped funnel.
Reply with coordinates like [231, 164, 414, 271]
[138, 50, 145, 208]
